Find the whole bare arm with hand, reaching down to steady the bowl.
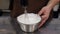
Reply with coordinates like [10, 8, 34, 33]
[38, 0, 59, 27]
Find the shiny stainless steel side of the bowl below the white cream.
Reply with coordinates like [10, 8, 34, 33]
[20, 23, 38, 32]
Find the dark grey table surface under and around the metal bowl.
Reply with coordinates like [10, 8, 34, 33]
[0, 17, 60, 34]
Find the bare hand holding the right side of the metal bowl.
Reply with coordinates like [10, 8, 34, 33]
[38, 6, 51, 27]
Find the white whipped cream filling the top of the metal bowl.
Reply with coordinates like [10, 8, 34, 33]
[17, 13, 41, 24]
